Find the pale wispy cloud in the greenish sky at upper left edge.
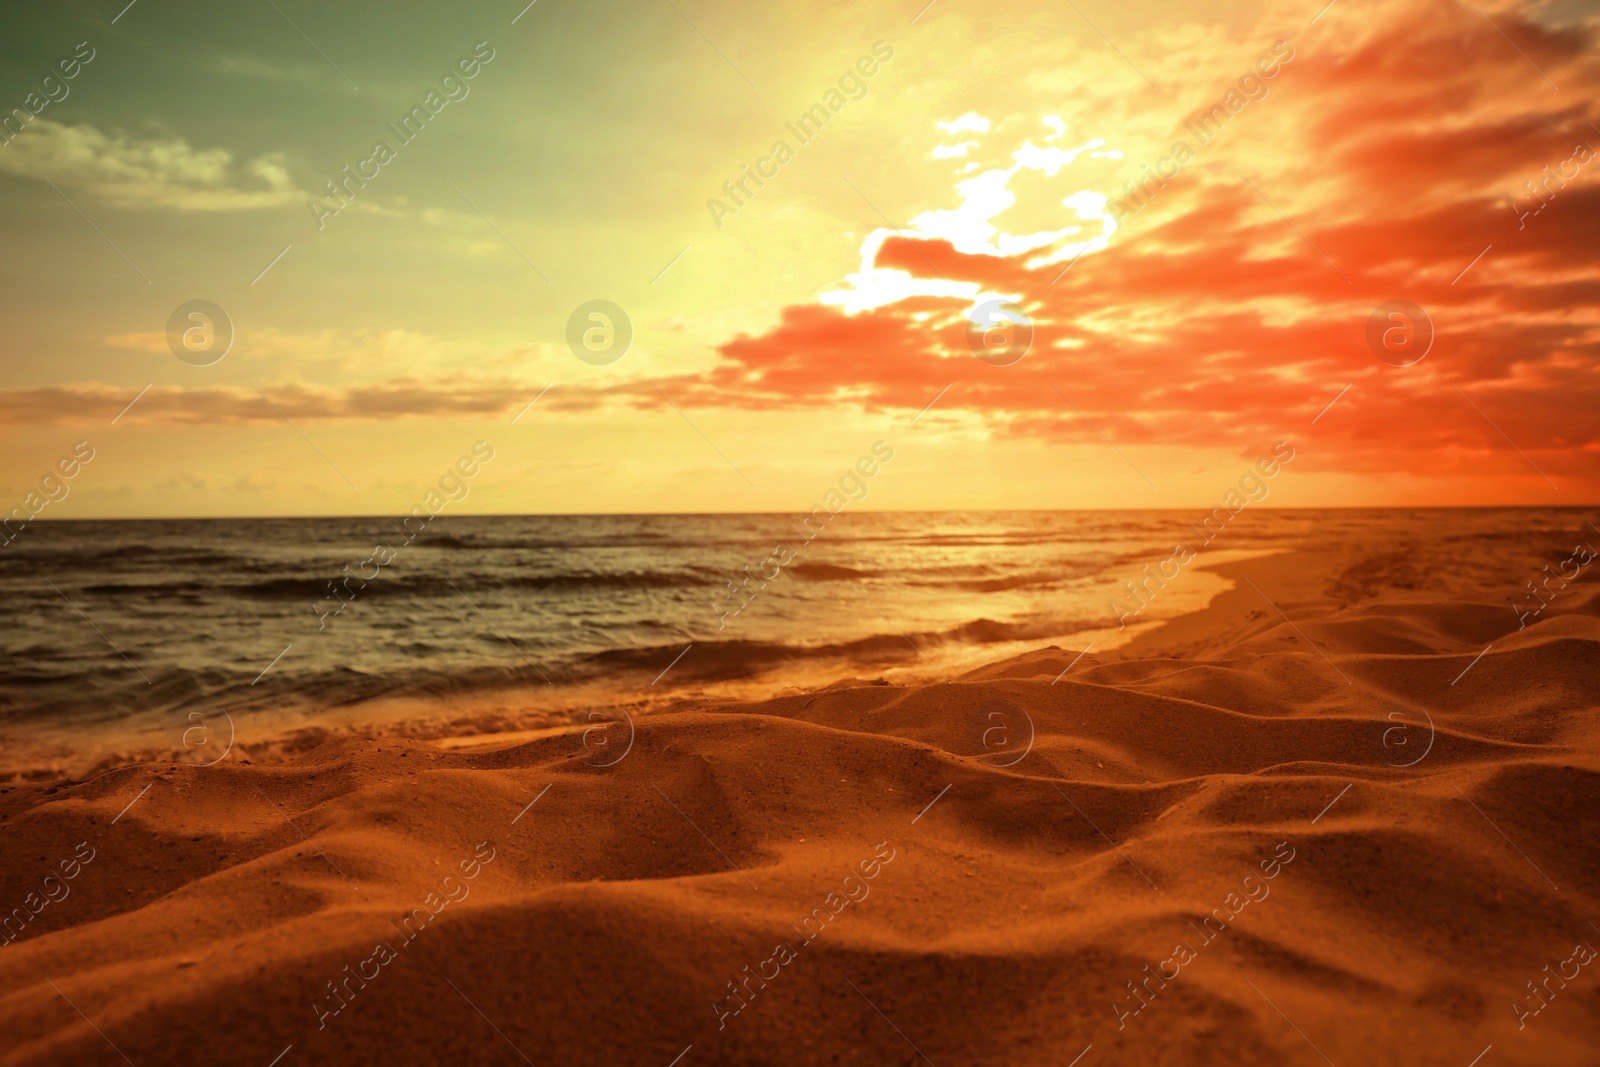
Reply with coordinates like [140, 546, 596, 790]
[0, 118, 306, 211]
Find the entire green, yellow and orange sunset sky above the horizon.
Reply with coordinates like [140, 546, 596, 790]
[0, 0, 1600, 518]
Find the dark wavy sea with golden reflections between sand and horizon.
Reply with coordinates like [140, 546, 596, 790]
[0, 509, 1570, 776]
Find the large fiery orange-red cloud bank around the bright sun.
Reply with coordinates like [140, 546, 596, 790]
[678, 3, 1600, 482]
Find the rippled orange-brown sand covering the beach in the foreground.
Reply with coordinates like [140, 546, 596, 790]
[0, 545, 1600, 1067]
